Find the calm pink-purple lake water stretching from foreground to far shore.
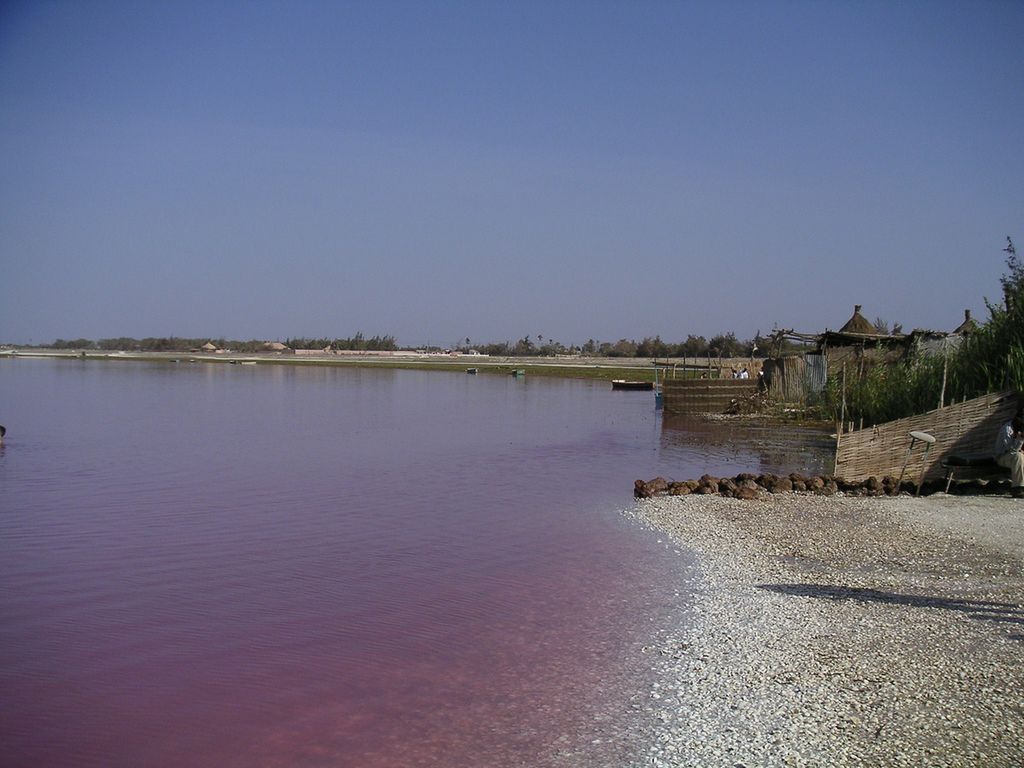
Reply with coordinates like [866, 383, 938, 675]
[0, 358, 824, 768]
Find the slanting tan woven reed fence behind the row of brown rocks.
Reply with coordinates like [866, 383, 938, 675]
[836, 390, 1021, 480]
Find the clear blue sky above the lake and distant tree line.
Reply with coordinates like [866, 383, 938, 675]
[0, 0, 1024, 344]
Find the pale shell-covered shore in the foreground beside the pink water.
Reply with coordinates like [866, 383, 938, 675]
[636, 494, 1024, 766]
